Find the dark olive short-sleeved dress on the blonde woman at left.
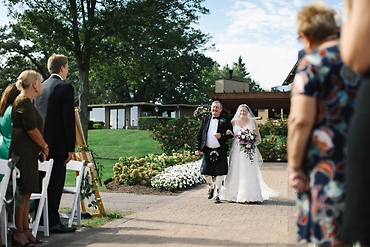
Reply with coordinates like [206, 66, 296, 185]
[9, 96, 44, 194]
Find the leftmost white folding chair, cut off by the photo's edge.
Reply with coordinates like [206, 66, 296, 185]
[0, 159, 16, 246]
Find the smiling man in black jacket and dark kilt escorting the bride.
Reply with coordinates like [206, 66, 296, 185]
[195, 100, 233, 203]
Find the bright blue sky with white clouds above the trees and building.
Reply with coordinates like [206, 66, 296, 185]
[0, 0, 343, 90]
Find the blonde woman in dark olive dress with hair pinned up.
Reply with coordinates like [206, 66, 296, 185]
[9, 70, 49, 247]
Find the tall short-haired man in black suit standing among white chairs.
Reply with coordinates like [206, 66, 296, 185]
[35, 54, 76, 233]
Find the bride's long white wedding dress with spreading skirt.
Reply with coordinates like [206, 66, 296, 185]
[220, 125, 279, 203]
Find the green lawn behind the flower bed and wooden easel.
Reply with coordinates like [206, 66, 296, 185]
[65, 129, 163, 188]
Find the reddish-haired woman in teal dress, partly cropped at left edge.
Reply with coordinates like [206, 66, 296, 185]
[0, 84, 20, 160]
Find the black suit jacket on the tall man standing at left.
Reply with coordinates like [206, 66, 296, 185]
[35, 75, 76, 158]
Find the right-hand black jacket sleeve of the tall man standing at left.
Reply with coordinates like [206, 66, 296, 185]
[62, 84, 76, 152]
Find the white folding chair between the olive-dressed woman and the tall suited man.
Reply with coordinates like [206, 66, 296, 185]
[30, 159, 54, 237]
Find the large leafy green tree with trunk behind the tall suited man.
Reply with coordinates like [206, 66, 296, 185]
[2, 0, 208, 139]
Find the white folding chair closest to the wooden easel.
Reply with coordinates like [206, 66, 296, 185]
[62, 160, 90, 227]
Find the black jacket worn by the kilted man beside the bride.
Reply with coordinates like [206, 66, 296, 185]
[195, 115, 233, 151]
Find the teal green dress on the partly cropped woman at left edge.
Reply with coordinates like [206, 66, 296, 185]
[0, 105, 12, 160]
